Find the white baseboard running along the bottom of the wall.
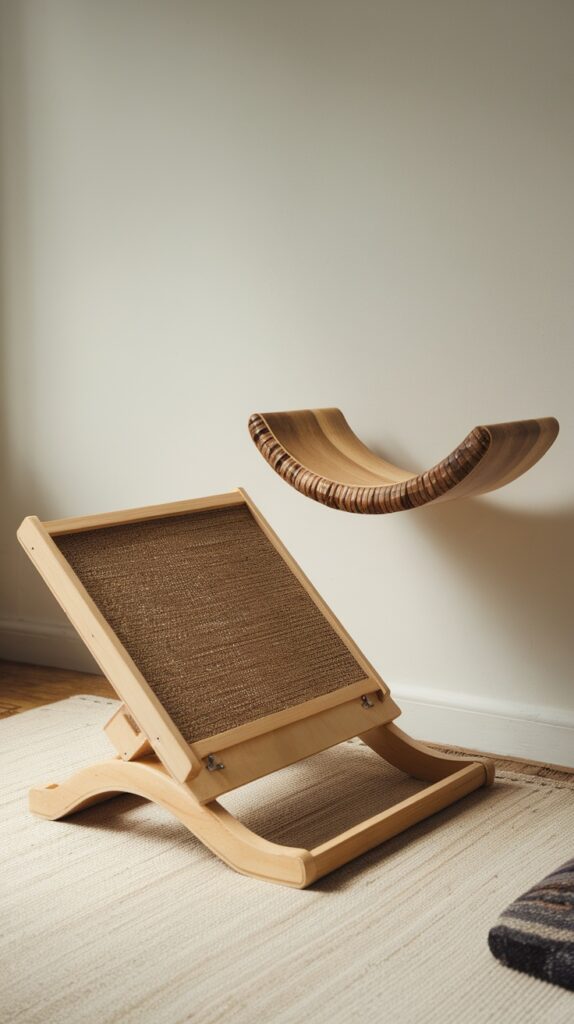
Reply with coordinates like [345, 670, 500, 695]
[0, 620, 574, 768]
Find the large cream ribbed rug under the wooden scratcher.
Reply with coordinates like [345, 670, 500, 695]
[0, 697, 574, 1024]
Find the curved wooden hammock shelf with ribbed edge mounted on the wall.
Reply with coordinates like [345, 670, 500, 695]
[249, 409, 559, 513]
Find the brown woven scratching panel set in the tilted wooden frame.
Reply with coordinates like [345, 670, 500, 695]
[55, 507, 364, 742]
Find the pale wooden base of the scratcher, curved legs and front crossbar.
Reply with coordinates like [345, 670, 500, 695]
[30, 724, 494, 889]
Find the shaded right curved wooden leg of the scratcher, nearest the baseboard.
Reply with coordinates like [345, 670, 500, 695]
[359, 722, 494, 785]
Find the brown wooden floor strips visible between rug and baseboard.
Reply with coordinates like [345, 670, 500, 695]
[0, 662, 574, 781]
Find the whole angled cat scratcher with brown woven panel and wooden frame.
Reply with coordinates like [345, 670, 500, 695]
[18, 490, 493, 888]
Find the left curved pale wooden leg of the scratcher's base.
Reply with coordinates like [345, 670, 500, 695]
[30, 758, 316, 889]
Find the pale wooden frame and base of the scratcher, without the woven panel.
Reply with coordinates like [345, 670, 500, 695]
[17, 489, 494, 887]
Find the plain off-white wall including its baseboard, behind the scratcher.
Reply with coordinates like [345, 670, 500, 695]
[0, 0, 574, 763]
